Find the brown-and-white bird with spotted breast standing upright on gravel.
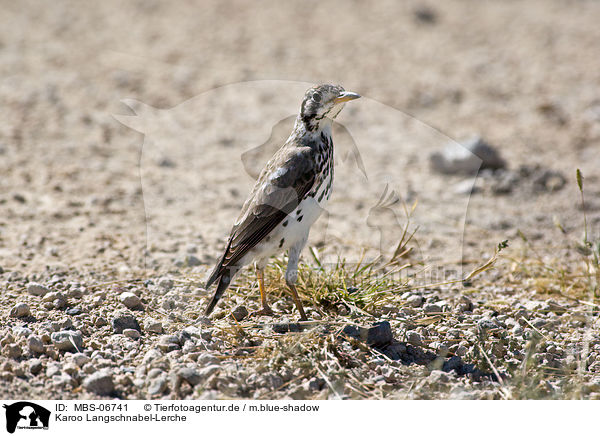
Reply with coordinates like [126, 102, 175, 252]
[205, 84, 360, 321]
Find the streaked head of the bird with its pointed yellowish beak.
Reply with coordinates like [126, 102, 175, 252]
[300, 85, 360, 130]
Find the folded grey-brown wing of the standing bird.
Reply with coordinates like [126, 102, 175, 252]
[206, 147, 317, 288]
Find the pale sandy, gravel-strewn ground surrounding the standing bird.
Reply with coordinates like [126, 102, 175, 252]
[0, 0, 600, 398]
